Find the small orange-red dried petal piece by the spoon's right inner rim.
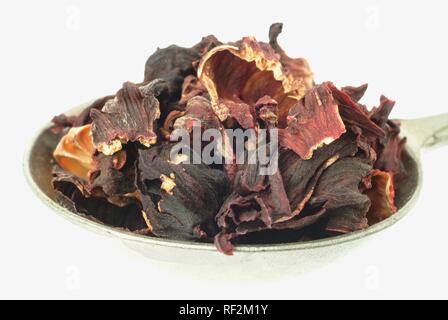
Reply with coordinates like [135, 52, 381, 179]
[365, 170, 397, 225]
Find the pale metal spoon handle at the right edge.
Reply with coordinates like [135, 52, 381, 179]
[401, 113, 448, 150]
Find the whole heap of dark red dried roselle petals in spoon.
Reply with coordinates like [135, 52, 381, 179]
[52, 24, 405, 254]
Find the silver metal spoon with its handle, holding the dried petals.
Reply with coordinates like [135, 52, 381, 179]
[24, 103, 448, 274]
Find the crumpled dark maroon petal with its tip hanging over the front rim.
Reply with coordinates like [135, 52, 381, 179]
[215, 156, 292, 255]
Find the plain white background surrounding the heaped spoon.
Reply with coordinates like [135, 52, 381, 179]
[0, 0, 448, 299]
